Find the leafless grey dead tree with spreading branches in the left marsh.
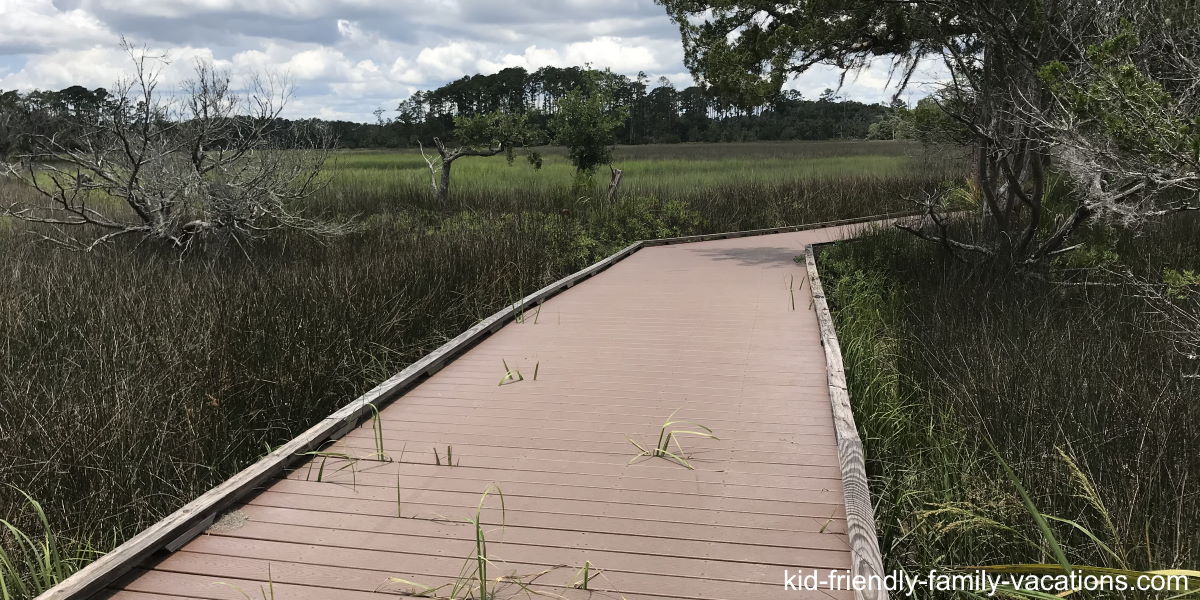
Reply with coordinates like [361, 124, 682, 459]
[0, 43, 350, 251]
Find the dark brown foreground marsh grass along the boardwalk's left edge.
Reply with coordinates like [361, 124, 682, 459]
[0, 208, 578, 589]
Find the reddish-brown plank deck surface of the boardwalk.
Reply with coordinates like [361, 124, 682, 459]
[105, 227, 873, 600]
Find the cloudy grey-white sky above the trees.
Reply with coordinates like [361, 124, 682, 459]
[0, 0, 940, 121]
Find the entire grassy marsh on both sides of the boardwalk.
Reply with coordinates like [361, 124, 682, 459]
[0, 142, 1200, 599]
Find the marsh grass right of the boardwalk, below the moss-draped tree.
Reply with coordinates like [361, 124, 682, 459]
[818, 216, 1200, 598]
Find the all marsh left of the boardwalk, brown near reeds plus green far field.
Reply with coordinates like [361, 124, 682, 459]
[0, 142, 966, 598]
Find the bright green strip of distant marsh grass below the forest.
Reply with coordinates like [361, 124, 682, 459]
[313, 142, 966, 226]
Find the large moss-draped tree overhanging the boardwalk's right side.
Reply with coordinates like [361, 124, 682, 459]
[658, 0, 1200, 266]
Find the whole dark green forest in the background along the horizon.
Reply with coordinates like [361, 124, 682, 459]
[0, 67, 904, 156]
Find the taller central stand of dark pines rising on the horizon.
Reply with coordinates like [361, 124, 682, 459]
[374, 67, 888, 146]
